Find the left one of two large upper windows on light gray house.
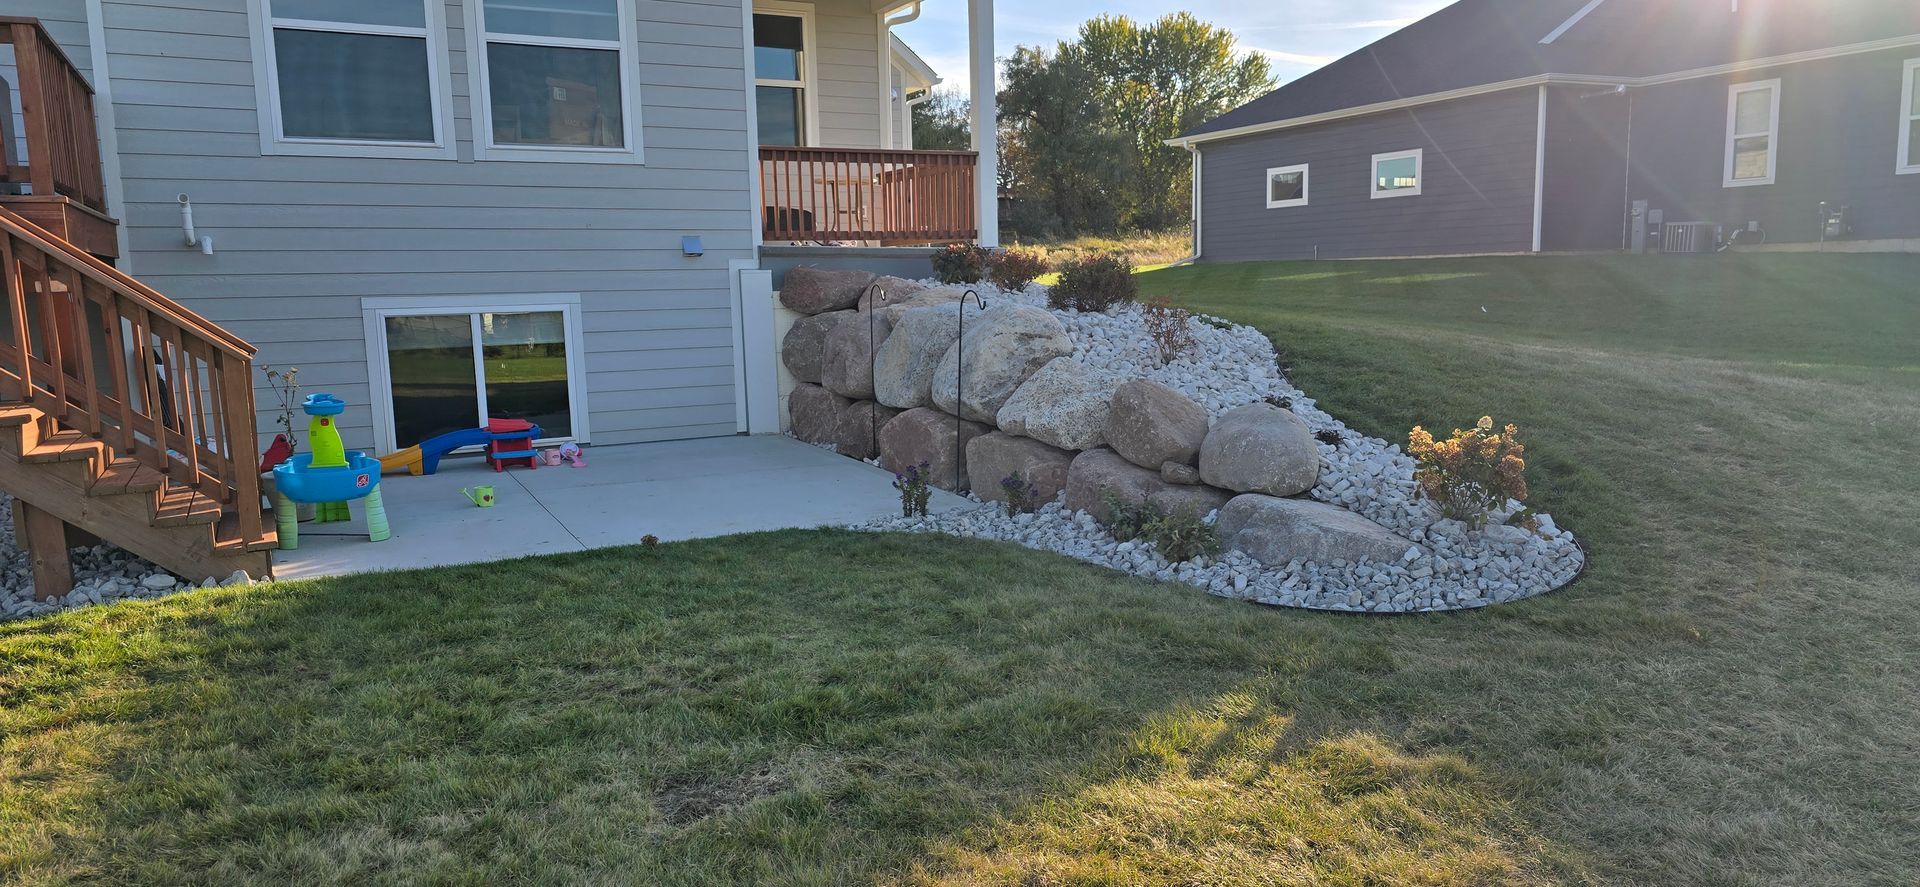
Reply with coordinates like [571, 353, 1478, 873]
[253, 0, 453, 157]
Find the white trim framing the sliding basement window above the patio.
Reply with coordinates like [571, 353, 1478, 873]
[361, 292, 591, 453]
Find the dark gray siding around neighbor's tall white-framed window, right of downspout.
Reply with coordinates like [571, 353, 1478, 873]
[1632, 48, 1920, 244]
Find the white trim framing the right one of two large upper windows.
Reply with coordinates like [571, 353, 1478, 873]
[461, 0, 647, 163]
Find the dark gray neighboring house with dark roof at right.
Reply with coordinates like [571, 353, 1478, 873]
[1169, 0, 1920, 261]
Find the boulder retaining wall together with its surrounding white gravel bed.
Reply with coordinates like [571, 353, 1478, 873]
[781, 269, 1586, 612]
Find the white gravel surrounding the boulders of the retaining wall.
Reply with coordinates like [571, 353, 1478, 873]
[862, 284, 1586, 612]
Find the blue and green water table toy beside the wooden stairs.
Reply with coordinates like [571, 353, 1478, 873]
[273, 394, 394, 551]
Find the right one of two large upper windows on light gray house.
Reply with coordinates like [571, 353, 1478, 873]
[467, 0, 639, 161]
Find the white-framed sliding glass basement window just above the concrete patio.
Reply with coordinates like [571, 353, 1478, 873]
[369, 297, 586, 447]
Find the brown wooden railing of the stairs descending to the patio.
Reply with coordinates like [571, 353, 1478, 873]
[0, 209, 263, 541]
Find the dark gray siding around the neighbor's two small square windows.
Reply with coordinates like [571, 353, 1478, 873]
[1200, 88, 1538, 261]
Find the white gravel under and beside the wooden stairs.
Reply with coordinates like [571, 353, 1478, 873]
[0, 493, 253, 622]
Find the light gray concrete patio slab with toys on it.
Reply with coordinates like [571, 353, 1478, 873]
[273, 436, 968, 580]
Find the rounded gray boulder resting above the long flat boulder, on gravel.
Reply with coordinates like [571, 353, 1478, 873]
[1200, 403, 1319, 495]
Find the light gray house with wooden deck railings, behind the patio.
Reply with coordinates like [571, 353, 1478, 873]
[0, 0, 996, 591]
